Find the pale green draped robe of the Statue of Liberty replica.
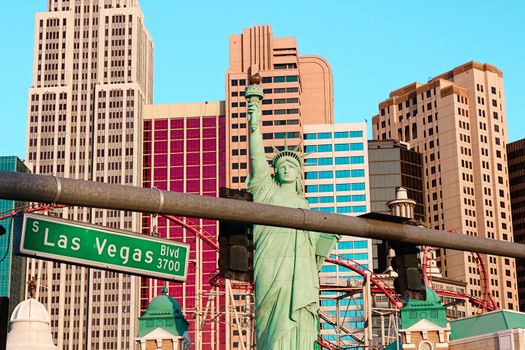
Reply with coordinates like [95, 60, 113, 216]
[247, 171, 319, 350]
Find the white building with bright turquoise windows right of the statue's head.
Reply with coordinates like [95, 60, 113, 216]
[304, 122, 372, 346]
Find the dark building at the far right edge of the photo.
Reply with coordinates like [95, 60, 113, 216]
[507, 139, 525, 311]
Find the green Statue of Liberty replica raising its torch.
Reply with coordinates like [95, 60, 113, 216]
[245, 74, 338, 350]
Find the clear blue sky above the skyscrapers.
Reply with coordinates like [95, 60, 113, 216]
[0, 0, 525, 158]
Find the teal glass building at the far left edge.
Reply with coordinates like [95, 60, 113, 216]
[0, 156, 29, 336]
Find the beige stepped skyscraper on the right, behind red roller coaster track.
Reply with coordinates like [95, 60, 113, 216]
[372, 62, 518, 311]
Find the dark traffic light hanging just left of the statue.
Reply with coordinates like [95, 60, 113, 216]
[219, 187, 253, 282]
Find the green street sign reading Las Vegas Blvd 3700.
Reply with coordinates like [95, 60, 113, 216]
[15, 214, 189, 282]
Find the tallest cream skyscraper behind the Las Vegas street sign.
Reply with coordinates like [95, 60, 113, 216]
[27, 0, 153, 349]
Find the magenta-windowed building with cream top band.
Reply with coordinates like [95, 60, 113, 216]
[140, 101, 228, 349]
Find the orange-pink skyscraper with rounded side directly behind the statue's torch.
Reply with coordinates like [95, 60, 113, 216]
[226, 25, 334, 189]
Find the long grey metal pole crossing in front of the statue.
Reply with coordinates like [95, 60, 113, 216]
[0, 171, 525, 259]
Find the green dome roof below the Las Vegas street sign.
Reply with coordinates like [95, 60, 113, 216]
[139, 287, 188, 337]
